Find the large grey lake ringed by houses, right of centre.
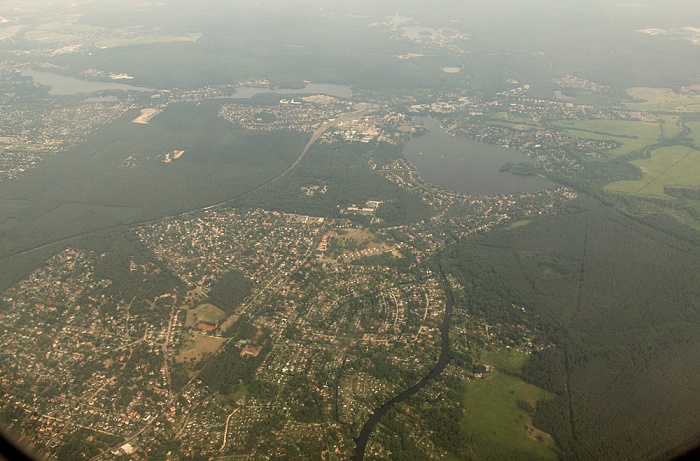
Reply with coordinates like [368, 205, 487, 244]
[403, 117, 557, 195]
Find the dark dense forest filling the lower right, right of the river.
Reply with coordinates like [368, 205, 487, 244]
[444, 196, 700, 460]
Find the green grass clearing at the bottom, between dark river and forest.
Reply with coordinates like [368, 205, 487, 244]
[462, 350, 557, 460]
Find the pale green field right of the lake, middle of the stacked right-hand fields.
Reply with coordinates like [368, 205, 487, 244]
[557, 120, 661, 157]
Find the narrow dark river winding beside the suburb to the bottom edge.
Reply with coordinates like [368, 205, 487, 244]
[352, 254, 454, 461]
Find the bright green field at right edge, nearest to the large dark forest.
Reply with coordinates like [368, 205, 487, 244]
[605, 146, 700, 198]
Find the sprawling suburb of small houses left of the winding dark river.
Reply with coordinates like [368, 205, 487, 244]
[0, 162, 573, 459]
